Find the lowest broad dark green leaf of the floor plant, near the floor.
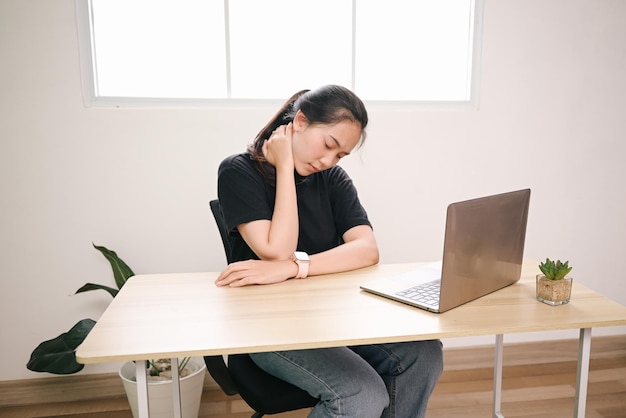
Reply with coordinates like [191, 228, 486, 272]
[26, 319, 96, 374]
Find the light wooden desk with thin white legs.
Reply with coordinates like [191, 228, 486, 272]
[76, 261, 626, 417]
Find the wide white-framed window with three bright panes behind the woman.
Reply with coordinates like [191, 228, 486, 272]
[77, 0, 484, 105]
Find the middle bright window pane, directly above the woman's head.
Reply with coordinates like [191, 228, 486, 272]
[229, 0, 352, 99]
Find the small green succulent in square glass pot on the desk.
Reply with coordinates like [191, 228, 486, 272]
[536, 258, 573, 306]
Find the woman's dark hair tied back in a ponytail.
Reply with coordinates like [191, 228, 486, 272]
[248, 85, 368, 182]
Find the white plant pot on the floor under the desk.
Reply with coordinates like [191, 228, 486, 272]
[120, 357, 206, 418]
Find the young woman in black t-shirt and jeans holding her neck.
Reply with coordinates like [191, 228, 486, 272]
[216, 85, 443, 418]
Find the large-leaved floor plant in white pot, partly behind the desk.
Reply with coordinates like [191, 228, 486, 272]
[26, 244, 206, 418]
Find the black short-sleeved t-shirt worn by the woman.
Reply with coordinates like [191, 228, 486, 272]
[217, 153, 371, 261]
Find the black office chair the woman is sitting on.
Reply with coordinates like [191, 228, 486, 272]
[204, 199, 319, 418]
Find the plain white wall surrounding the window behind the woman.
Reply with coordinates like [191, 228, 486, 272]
[0, 0, 626, 380]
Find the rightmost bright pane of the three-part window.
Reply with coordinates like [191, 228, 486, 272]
[355, 0, 474, 101]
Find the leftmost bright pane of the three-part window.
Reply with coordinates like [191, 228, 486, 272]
[92, 0, 226, 98]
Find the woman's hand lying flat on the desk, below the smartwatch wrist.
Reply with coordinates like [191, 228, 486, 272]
[215, 260, 298, 287]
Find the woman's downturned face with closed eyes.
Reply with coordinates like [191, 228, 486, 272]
[292, 111, 362, 176]
